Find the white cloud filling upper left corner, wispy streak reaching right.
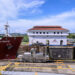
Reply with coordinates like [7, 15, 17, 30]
[0, 0, 45, 21]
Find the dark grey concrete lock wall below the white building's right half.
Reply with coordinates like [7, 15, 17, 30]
[49, 48, 73, 60]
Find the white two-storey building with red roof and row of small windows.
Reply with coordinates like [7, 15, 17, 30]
[28, 26, 69, 45]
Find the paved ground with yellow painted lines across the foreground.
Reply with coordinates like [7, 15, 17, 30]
[0, 62, 75, 75]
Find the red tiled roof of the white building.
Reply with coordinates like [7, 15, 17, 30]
[29, 26, 67, 30]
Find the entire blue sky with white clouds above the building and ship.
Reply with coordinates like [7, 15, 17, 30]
[0, 0, 75, 33]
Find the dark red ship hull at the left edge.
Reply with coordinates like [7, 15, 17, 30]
[0, 37, 22, 59]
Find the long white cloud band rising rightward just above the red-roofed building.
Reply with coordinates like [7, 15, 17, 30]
[4, 11, 75, 33]
